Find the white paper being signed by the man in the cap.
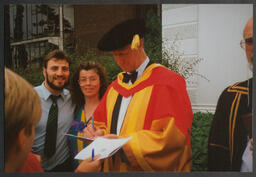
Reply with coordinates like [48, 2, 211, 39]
[75, 137, 132, 160]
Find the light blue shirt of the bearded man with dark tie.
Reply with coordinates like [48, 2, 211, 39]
[32, 82, 75, 170]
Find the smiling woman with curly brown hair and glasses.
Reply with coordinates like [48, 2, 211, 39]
[69, 62, 107, 165]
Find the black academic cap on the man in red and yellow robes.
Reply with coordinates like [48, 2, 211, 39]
[97, 18, 145, 51]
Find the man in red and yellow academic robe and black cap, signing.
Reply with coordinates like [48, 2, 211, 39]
[84, 19, 193, 172]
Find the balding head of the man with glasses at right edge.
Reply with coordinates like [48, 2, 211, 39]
[243, 17, 253, 64]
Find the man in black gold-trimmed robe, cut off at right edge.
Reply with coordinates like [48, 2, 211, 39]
[208, 17, 253, 172]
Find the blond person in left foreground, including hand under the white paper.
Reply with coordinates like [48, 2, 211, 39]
[4, 68, 101, 172]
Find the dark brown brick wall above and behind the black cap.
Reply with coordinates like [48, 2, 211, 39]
[74, 4, 157, 54]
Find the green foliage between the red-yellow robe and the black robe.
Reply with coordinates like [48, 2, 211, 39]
[191, 112, 213, 171]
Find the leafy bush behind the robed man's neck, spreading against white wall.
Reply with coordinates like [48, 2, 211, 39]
[144, 10, 204, 80]
